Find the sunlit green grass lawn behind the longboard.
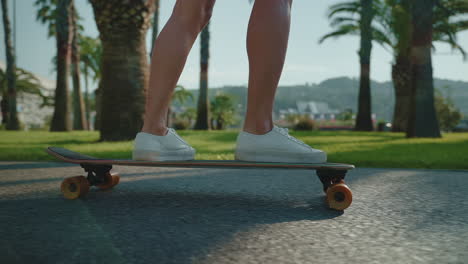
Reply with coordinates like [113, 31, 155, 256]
[0, 131, 468, 169]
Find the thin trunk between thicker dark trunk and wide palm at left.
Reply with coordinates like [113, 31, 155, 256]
[70, 4, 87, 130]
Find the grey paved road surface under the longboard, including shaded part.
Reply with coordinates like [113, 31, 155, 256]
[0, 162, 468, 264]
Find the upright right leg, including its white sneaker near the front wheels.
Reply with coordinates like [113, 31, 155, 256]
[235, 0, 327, 163]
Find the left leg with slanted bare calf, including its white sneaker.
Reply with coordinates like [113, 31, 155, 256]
[133, 0, 216, 161]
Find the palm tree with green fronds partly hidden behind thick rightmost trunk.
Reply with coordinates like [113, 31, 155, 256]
[382, 0, 468, 132]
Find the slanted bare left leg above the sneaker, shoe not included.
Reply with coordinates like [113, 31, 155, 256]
[142, 0, 216, 136]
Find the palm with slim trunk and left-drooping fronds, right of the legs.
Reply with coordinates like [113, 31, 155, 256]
[319, 0, 377, 131]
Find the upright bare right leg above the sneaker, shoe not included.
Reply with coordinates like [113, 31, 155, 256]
[244, 0, 292, 135]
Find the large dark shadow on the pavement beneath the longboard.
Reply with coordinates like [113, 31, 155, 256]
[0, 170, 342, 263]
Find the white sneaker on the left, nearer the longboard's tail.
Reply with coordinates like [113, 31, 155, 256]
[133, 128, 195, 161]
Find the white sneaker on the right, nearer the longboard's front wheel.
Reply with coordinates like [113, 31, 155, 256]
[236, 126, 327, 163]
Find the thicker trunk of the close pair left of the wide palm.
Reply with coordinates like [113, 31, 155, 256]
[50, 0, 73, 131]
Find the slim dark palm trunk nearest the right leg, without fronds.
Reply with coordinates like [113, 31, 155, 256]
[355, 0, 374, 131]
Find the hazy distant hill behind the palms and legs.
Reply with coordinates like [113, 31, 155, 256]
[180, 77, 468, 121]
